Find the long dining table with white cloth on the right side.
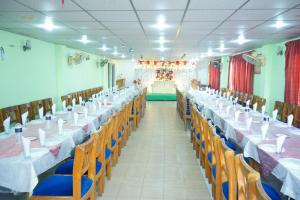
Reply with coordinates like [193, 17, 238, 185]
[186, 89, 300, 199]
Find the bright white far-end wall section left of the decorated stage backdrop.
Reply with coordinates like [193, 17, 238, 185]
[116, 60, 135, 84]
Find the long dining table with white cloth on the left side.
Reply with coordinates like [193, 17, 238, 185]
[0, 86, 142, 194]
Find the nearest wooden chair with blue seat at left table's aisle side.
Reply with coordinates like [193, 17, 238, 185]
[30, 137, 96, 200]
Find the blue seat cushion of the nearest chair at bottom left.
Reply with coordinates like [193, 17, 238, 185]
[32, 176, 93, 197]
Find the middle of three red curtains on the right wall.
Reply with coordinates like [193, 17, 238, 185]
[228, 54, 254, 94]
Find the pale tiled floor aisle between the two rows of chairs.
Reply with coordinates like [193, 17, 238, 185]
[98, 102, 211, 200]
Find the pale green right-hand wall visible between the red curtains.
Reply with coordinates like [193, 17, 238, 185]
[221, 36, 298, 114]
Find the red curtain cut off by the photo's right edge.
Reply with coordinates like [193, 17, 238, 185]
[285, 40, 300, 105]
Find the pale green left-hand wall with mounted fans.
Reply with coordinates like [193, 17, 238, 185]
[0, 31, 107, 108]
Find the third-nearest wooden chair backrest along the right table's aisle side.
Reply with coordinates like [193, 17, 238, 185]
[218, 140, 237, 200]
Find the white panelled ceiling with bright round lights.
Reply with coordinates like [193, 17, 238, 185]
[0, 0, 300, 58]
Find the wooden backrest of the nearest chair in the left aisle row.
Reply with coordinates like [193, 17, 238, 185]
[73, 135, 97, 199]
